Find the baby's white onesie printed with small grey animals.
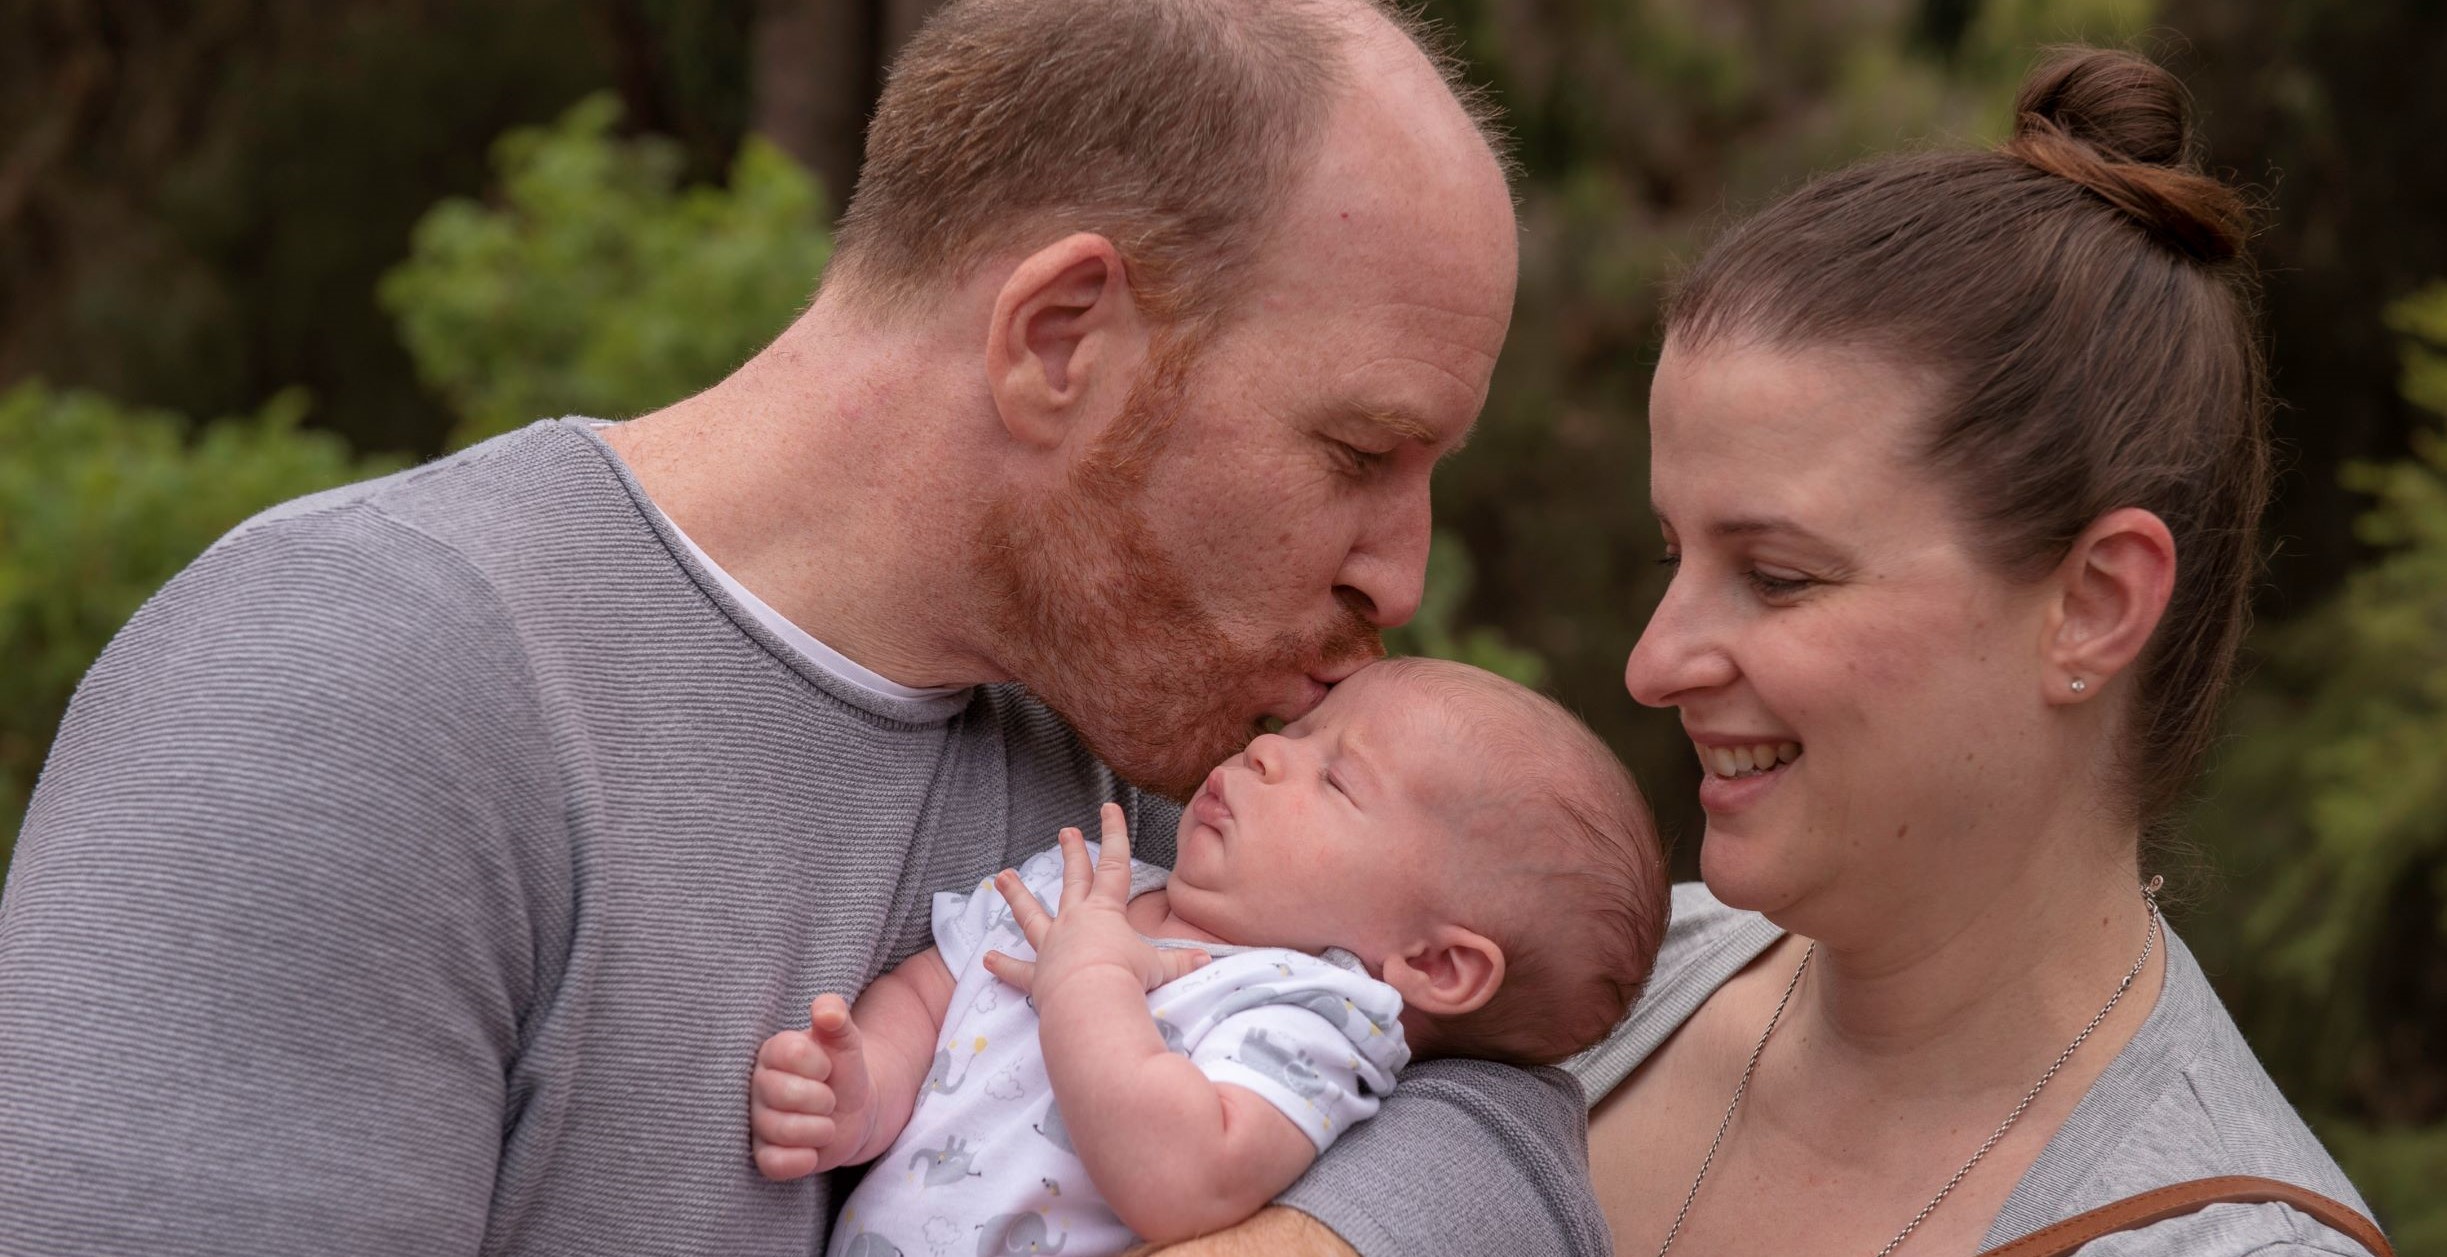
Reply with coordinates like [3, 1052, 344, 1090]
[830, 844, 1409, 1257]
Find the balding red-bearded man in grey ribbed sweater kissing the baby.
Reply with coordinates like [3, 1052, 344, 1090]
[0, 0, 1603, 1255]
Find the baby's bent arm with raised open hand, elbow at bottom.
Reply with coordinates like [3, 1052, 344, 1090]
[986, 805, 1316, 1242]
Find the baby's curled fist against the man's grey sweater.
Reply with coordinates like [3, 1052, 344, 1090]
[749, 995, 876, 1184]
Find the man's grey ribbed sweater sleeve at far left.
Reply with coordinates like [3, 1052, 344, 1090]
[0, 504, 568, 1255]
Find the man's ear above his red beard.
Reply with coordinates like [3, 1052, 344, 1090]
[986, 232, 1148, 450]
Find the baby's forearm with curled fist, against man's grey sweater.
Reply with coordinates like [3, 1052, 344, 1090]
[749, 946, 952, 1181]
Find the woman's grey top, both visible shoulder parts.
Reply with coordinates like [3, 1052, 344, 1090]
[1566, 883, 2369, 1257]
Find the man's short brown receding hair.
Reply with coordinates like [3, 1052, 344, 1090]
[827, 0, 1500, 323]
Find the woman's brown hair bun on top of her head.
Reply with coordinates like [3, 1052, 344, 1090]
[2004, 49, 2251, 264]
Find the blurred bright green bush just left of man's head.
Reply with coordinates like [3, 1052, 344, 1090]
[382, 95, 832, 445]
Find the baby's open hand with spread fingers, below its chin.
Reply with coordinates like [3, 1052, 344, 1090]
[986, 802, 1206, 1003]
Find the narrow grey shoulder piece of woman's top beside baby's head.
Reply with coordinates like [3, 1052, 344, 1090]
[1564, 883, 1784, 1103]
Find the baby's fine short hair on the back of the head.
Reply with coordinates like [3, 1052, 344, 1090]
[1378, 658, 1669, 1064]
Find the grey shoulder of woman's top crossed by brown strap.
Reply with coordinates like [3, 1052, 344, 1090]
[1987, 919, 2369, 1257]
